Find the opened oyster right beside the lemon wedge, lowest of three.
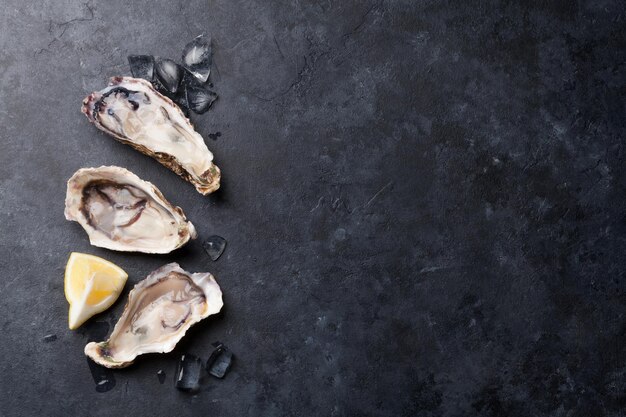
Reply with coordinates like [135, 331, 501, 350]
[85, 263, 219, 368]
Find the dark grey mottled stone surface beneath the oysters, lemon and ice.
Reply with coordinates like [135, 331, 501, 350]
[0, 0, 626, 417]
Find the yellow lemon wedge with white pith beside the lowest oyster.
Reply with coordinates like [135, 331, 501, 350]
[65, 252, 128, 330]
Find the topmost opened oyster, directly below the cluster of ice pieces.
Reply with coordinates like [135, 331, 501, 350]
[82, 77, 220, 195]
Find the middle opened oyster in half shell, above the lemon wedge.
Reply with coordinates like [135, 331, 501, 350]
[65, 166, 196, 253]
